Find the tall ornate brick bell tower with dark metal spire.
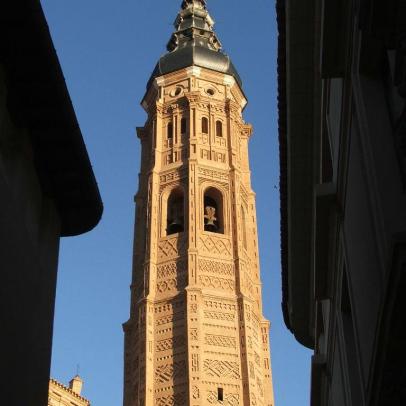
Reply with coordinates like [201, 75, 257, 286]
[124, 0, 274, 406]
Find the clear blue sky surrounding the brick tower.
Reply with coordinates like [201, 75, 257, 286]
[41, 0, 311, 406]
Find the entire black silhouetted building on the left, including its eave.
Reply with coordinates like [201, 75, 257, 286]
[0, 0, 103, 406]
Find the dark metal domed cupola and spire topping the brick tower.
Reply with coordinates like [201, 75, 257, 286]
[147, 0, 242, 86]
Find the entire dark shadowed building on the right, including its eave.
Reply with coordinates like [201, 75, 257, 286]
[277, 0, 406, 406]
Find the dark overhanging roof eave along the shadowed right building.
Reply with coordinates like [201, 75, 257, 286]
[276, 0, 315, 348]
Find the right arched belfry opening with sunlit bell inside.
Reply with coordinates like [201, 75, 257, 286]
[203, 186, 225, 234]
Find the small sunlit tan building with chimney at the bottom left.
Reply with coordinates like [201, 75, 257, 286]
[48, 375, 90, 406]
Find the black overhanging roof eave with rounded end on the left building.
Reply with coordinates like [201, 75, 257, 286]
[0, 0, 103, 236]
